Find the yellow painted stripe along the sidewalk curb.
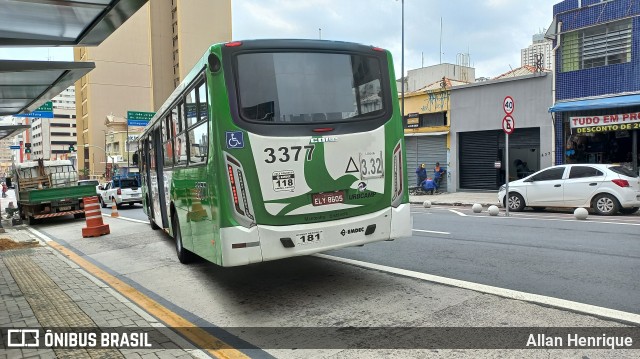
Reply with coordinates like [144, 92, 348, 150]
[47, 241, 249, 359]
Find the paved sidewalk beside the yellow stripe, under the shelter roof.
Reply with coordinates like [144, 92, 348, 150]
[0, 226, 204, 359]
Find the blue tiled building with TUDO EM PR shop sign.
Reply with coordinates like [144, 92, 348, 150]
[547, 0, 640, 171]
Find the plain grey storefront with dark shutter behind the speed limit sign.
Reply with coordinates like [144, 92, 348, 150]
[448, 72, 553, 191]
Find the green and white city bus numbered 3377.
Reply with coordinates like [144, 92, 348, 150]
[139, 40, 411, 267]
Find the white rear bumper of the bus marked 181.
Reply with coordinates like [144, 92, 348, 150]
[221, 204, 412, 267]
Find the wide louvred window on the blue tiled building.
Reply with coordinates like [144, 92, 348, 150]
[562, 19, 632, 72]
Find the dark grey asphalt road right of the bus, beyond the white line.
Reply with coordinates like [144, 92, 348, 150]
[328, 206, 640, 313]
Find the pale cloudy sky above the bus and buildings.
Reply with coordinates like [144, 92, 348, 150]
[0, 0, 560, 78]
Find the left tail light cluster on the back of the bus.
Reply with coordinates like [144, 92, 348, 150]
[226, 154, 255, 227]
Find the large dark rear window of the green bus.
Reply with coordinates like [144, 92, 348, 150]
[237, 52, 389, 123]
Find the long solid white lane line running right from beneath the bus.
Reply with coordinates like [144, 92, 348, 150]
[314, 253, 640, 325]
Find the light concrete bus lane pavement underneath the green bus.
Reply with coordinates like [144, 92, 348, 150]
[27, 218, 638, 358]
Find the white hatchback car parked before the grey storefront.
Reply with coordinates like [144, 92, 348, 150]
[498, 164, 640, 215]
